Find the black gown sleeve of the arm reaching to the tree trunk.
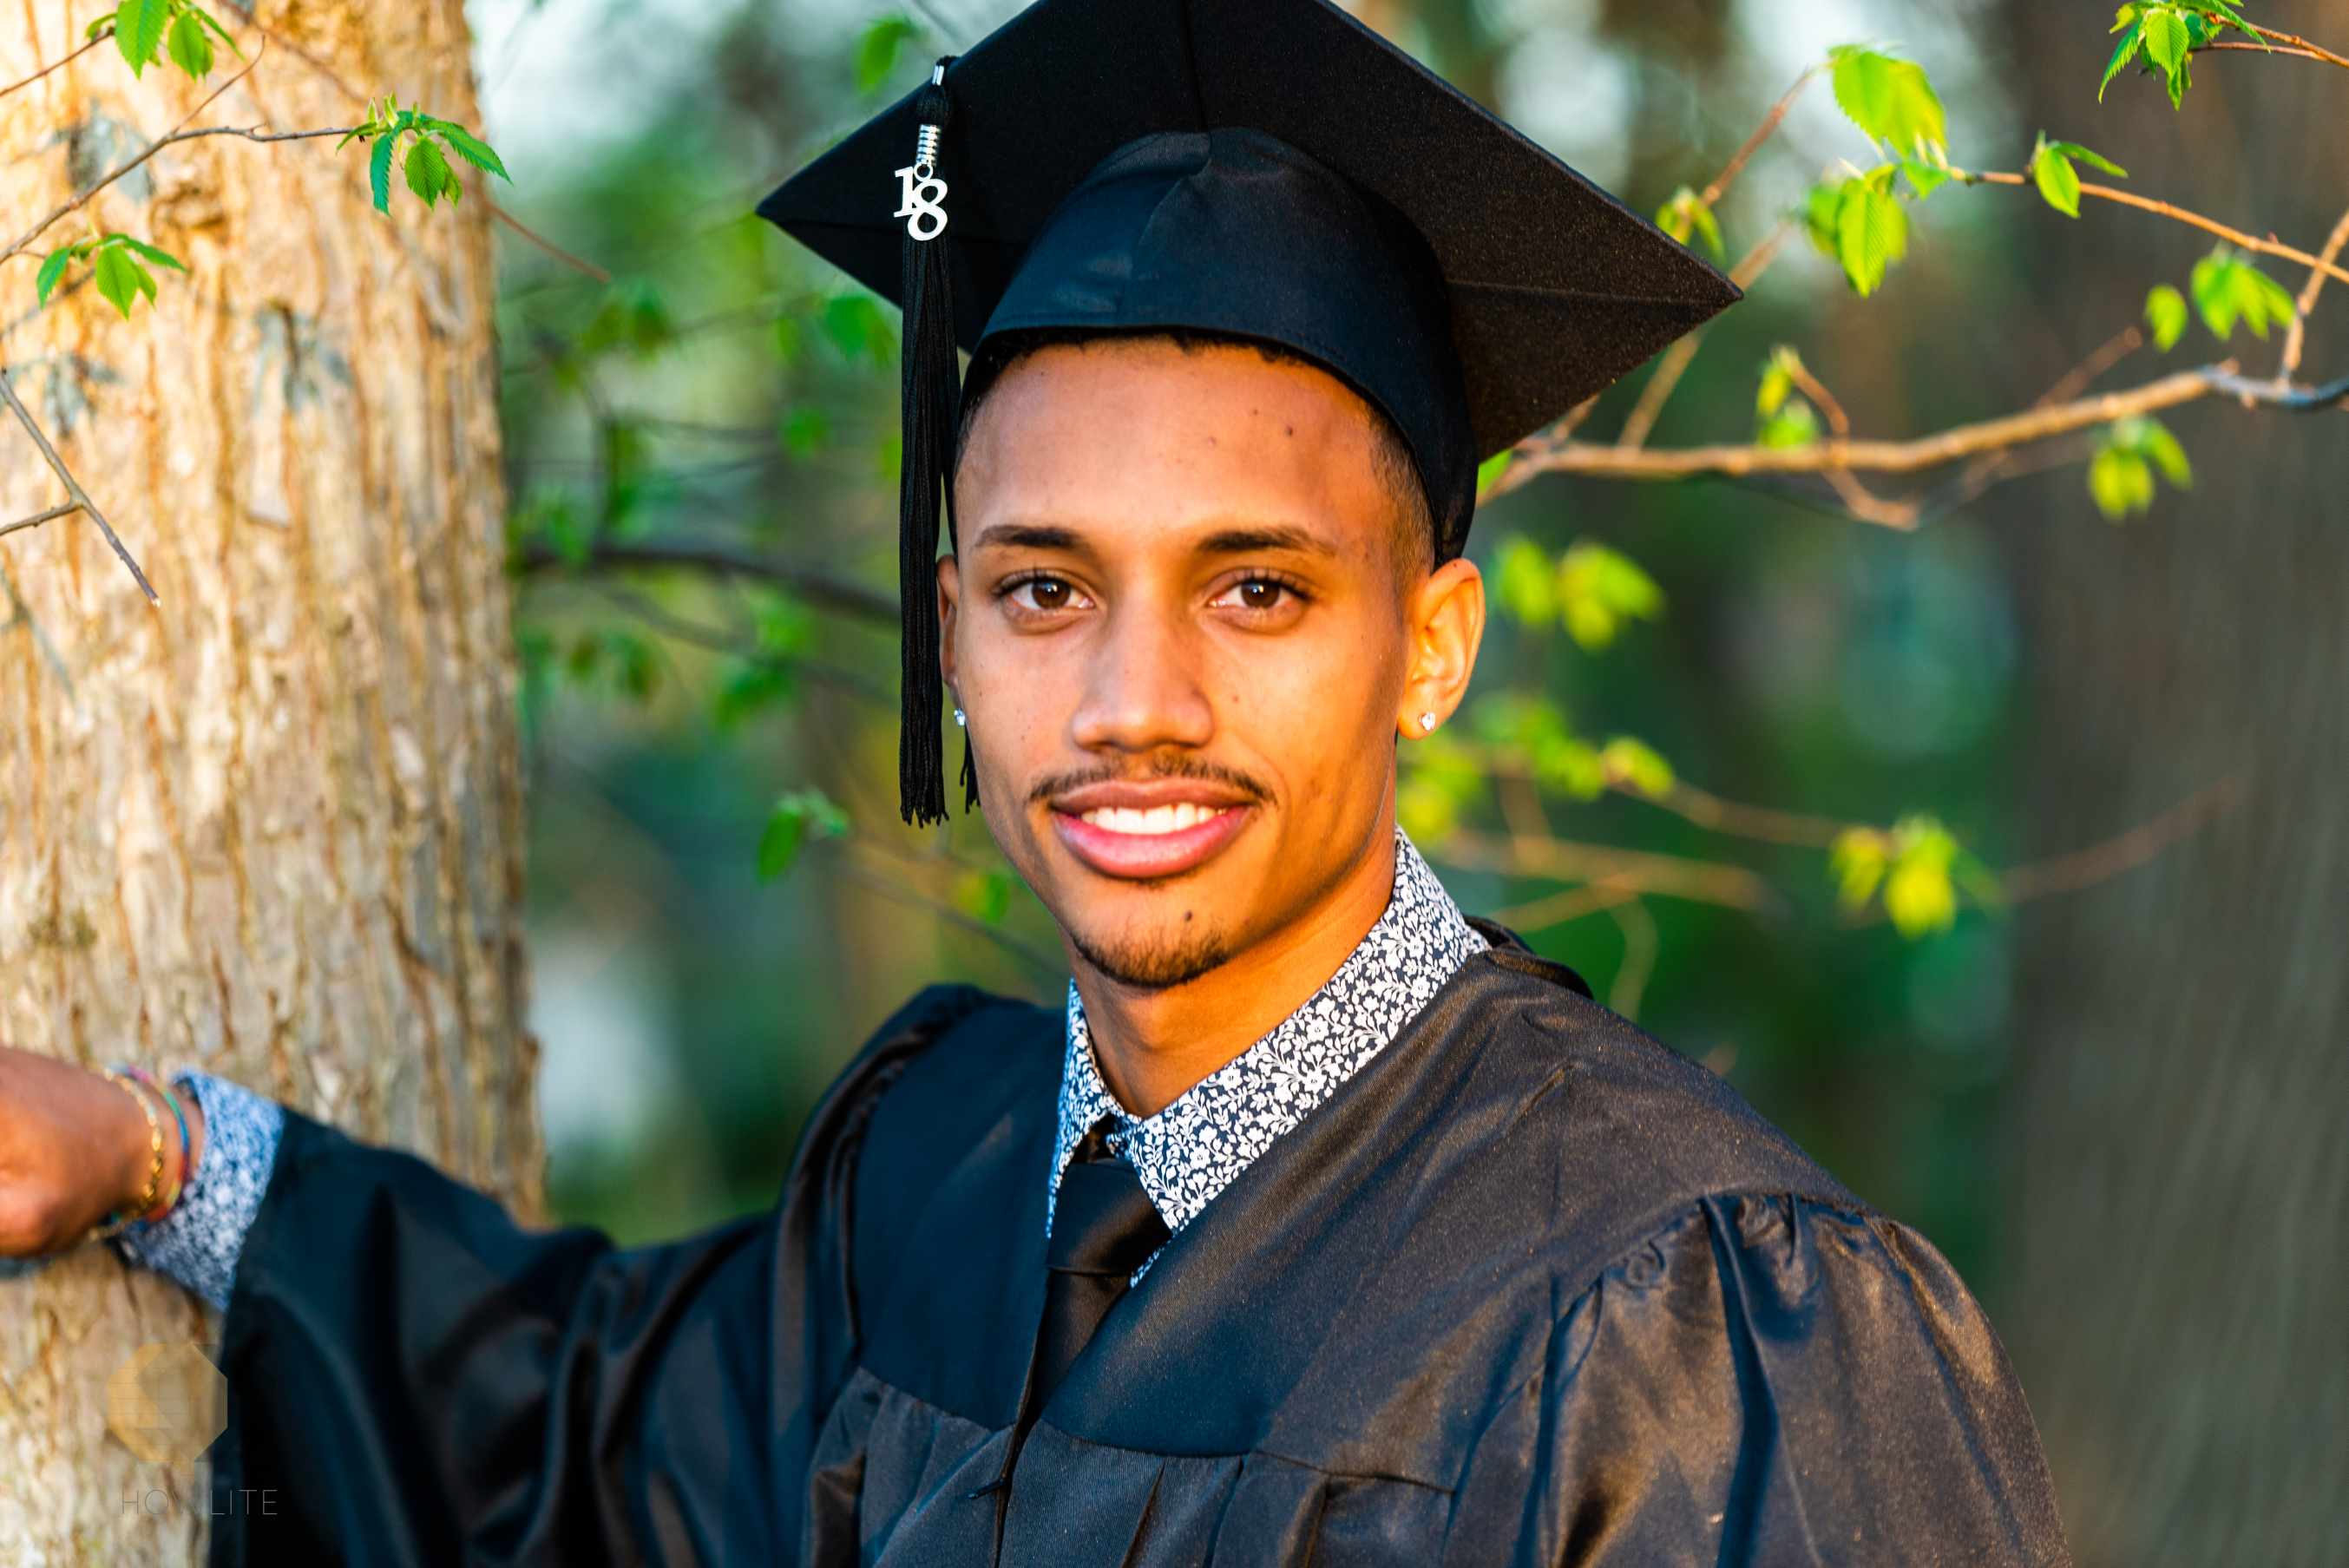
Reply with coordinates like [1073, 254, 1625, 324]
[209, 986, 1001, 1568]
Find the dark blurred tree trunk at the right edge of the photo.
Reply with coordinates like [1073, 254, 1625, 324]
[1992, 0, 2349, 1568]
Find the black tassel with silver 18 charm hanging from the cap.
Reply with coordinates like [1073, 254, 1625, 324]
[897, 54, 958, 826]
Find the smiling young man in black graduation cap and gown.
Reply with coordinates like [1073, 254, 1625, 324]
[0, 0, 2067, 1564]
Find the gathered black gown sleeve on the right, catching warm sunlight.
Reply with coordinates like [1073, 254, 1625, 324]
[1527, 1195, 2072, 1568]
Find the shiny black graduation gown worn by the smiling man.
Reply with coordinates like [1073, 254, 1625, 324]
[212, 922, 2070, 1568]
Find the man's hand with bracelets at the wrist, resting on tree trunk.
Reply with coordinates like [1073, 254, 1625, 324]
[0, 1045, 202, 1258]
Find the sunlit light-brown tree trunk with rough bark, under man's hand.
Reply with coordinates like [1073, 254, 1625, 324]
[0, 0, 542, 1564]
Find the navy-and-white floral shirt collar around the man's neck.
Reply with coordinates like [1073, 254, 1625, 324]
[1046, 826, 1489, 1249]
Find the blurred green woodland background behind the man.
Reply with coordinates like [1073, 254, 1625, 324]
[469, 0, 2349, 1564]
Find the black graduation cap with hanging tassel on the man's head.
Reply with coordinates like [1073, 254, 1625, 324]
[758, 0, 1741, 823]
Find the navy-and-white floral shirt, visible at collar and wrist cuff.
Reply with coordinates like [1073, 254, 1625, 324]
[113, 826, 1487, 1312]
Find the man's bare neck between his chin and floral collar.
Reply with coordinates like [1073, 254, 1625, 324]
[1071, 823, 1395, 1118]
